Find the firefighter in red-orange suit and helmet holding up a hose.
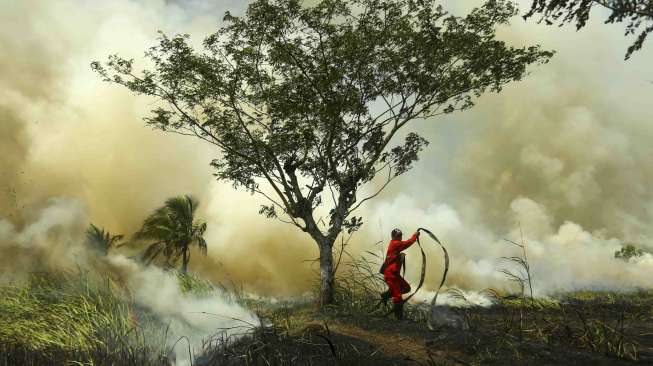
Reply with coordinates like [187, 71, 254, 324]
[381, 229, 419, 320]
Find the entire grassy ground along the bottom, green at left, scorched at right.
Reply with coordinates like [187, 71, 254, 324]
[0, 264, 653, 366]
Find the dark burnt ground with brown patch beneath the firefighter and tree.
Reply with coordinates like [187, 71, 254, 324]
[196, 295, 653, 365]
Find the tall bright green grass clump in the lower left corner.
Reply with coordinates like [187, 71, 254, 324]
[0, 273, 171, 365]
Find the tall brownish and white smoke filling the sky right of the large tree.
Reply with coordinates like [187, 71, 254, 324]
[360, 2, 653, 294]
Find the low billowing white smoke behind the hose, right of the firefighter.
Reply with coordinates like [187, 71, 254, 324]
[362, 195, 653, 302]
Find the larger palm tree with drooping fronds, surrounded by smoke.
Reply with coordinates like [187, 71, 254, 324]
[134, 195, 207, 273]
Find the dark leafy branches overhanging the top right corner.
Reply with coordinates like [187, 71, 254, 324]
[524, 0, 653, 59]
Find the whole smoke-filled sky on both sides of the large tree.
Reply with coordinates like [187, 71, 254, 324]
[0, 0, 653, 296]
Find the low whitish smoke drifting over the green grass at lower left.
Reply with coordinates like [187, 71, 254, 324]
[0, 198, 259, 365]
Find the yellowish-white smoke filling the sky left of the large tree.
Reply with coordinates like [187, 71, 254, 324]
[0, 0, 315, 295]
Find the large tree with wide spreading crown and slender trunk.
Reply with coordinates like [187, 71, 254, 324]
[92, 0, 552, 304]
